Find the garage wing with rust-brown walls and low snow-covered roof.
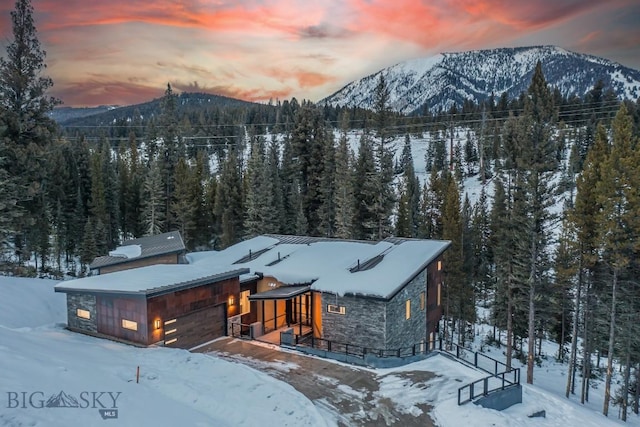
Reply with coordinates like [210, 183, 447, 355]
[55, 264, 249, 348]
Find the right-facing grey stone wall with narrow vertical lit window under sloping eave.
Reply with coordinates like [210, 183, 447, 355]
[385, 269, 427, 349]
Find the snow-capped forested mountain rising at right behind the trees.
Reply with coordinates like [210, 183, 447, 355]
[319, 46, 640, 114]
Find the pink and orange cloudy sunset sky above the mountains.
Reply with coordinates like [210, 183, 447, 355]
[0, 0, 640, 106]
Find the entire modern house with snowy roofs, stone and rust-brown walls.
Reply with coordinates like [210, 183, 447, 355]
[55, 233, 450, 354]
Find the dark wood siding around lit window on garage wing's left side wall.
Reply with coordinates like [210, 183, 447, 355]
[96, 295, 149, 344]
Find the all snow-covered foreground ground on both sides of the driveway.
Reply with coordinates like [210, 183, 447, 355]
[0, 276, 640, 427]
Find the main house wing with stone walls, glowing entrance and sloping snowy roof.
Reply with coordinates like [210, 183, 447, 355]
[187, 235, 450, 351]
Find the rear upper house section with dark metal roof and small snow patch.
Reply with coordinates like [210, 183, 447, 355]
[89, 231, 186, 274]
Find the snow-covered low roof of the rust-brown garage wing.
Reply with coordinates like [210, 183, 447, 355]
[55, 264, 249, 297]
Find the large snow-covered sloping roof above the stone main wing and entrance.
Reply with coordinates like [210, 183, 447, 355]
[187, 235, 450, 298]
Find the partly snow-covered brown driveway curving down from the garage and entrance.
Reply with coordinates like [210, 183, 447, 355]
[195, 338, 435, 427]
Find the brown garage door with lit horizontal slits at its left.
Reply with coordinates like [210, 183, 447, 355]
[164, 304, 227, 348]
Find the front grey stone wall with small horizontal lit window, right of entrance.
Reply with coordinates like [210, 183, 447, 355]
[322, 293, 386, 349]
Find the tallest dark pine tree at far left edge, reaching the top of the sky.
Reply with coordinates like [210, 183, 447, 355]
[0, 0, 59, 260]
